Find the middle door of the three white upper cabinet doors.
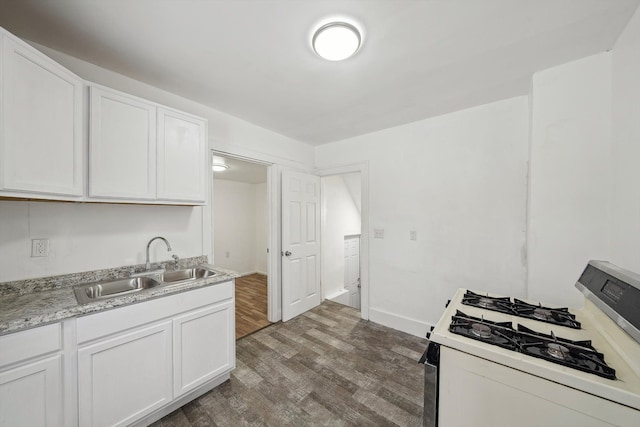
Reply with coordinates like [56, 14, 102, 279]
[89, 86, 156, 200]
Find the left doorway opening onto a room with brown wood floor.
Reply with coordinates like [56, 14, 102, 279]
[212, 154, 271, 339]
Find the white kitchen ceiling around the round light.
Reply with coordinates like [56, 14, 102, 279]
[0, 0, 640, 145]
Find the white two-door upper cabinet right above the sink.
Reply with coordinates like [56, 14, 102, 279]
[89, 85, 207, 205]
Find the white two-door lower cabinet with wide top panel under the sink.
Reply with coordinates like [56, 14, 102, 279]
[77, 281, 235, 427]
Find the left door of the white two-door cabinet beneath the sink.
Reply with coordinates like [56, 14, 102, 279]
[78, 321, 172, 426]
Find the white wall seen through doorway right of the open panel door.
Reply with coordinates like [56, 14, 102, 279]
[320, 173, 361, 300]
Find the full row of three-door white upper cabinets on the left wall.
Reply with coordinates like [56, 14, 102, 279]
[0, 28, 208, 205]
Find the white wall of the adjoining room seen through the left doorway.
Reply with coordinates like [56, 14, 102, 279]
[213, 179, 268, 274]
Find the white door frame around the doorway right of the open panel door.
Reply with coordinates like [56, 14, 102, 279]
[314, 161, 369, 320]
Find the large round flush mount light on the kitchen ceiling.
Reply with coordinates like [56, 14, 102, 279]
[311, 22, 362, 61]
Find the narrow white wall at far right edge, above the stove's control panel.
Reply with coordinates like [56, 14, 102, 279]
[611, 5, 640, 273]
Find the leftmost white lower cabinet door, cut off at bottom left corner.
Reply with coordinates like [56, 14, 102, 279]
[0, 355, 62, 427]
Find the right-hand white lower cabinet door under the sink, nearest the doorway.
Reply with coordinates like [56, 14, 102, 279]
[173, 301, 235, 397]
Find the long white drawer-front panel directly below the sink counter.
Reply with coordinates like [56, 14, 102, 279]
[78, 281, 233, 344]
